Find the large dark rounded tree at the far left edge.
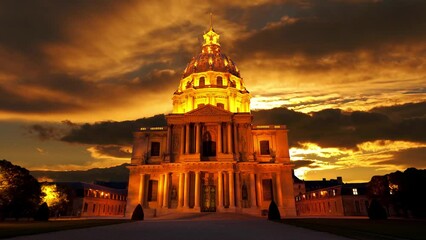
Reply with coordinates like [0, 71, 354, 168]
[0, 160, 41, 220]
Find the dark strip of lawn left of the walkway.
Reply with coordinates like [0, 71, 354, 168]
[0, 219, 129, 238]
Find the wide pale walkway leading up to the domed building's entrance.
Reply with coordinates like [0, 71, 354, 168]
[8, 213, 347, 240]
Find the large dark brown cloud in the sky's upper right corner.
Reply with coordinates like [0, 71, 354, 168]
[237, 0, 426, 58]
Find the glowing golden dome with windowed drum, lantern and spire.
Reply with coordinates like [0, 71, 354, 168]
[173, 15, 251, 113]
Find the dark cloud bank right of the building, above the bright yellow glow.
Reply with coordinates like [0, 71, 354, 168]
[253, 102, 426, 148]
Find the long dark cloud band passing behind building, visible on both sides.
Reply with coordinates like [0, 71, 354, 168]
[55, 102, 426, 149]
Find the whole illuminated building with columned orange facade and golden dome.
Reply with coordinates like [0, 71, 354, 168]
[126, 24, 296, 217]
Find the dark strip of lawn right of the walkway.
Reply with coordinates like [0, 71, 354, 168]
[282, 218, 426, 240]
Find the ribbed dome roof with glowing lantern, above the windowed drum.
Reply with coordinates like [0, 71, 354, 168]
[183, 28, 241, 78]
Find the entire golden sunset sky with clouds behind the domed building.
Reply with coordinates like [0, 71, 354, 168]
[0, 0, 426, 182]
